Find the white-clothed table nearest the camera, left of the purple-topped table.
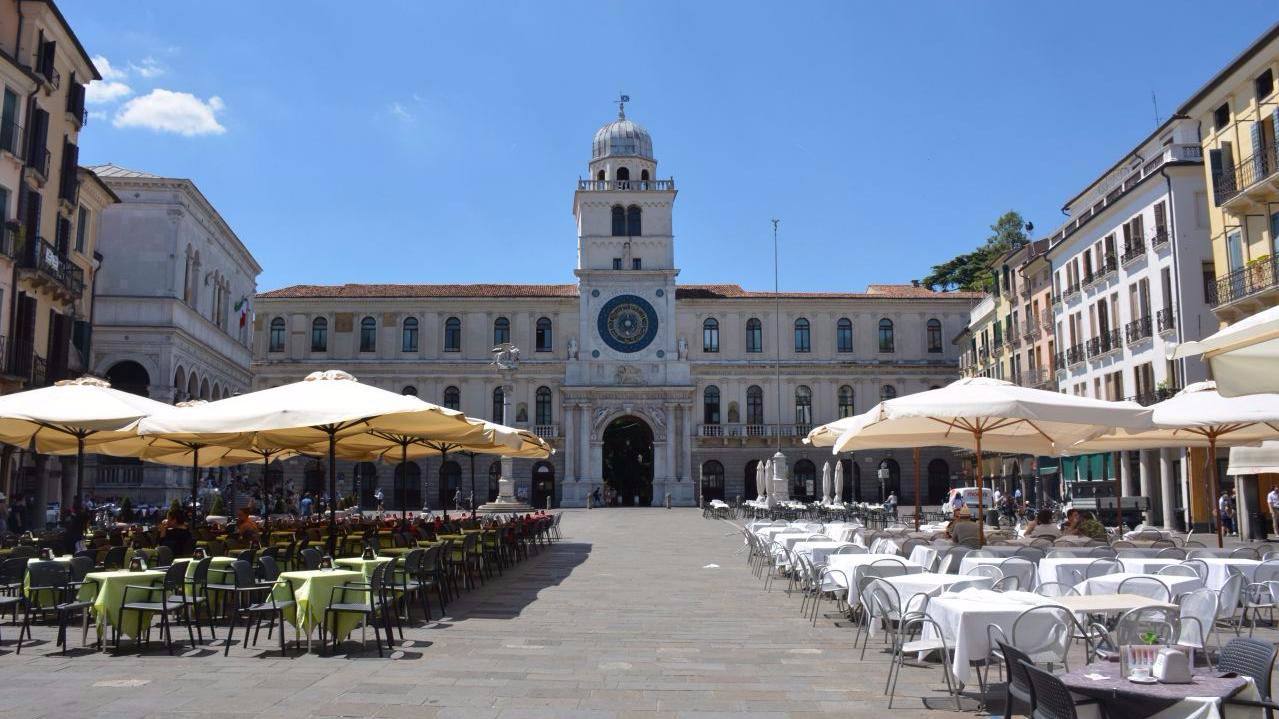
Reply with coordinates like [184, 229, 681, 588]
[923, 589, 1056, 683]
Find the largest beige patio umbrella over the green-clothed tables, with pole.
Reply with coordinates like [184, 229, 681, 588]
[138, 370, 482, 554]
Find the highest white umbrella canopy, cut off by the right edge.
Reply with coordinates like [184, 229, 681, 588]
[1169, 307, 1279, 397]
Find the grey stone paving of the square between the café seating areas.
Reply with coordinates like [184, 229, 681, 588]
[0, 509, 1028, 719]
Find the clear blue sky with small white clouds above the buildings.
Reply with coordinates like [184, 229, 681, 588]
[59, 0, 1279, 290]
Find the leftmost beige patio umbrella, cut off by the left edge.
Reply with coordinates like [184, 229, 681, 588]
[0, 376, 170, 496]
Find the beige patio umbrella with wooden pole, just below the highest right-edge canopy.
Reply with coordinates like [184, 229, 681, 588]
[1065, 381, 1279, 546]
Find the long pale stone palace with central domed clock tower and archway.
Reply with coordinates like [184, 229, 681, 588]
[253, 107, 981, 508]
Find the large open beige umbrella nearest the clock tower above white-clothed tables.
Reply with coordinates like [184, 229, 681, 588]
[831, 377, 1150, 541]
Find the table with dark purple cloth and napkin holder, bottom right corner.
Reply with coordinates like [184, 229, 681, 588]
[1059, 661, 1261, 719]
